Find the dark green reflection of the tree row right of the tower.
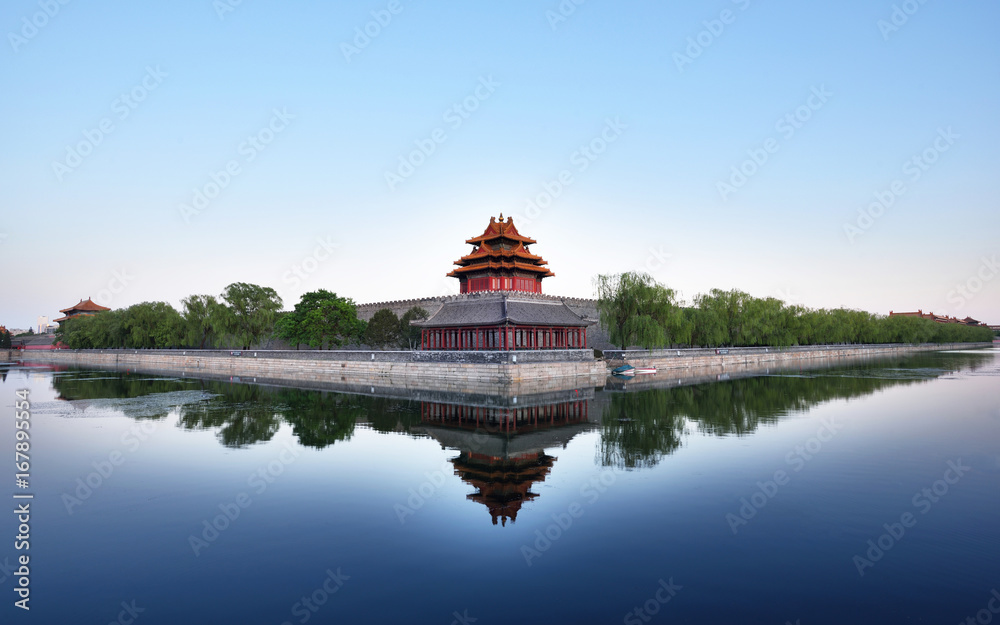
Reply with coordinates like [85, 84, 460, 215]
[599, 354, 988, 469]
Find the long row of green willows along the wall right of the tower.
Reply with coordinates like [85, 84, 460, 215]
[595, 272, 993, 349]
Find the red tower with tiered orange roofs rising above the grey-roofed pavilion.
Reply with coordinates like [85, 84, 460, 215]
[448, 213, 555, 293]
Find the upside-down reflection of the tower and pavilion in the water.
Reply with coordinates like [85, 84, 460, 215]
[420, 398, 591, 526]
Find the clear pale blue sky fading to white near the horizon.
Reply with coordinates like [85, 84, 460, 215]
[0, 0, 1000, 328]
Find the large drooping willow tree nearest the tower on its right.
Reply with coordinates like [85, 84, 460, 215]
[594, 271, 688, 349]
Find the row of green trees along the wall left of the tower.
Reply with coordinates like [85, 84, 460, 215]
[56, 282, 427, 349]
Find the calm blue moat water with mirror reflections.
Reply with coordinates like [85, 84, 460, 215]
[0, 350, 1000, 625]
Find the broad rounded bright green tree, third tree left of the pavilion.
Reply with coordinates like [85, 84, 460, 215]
[276, 289, 364, 349]
